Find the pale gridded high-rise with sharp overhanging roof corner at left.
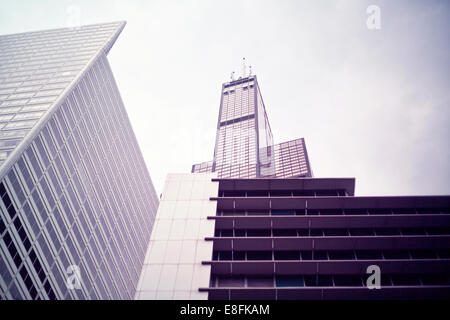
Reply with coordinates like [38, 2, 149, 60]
[0, 22, 159, 299]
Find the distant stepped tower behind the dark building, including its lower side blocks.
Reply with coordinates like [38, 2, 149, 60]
[191, 76, 312, 178]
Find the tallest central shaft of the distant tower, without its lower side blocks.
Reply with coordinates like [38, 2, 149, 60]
[213, 76, 275, 178]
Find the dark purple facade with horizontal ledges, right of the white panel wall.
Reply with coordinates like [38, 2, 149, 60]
[206, 178, 450, 299]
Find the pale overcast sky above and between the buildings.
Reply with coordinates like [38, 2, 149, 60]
[0, 0, 450, 195]
